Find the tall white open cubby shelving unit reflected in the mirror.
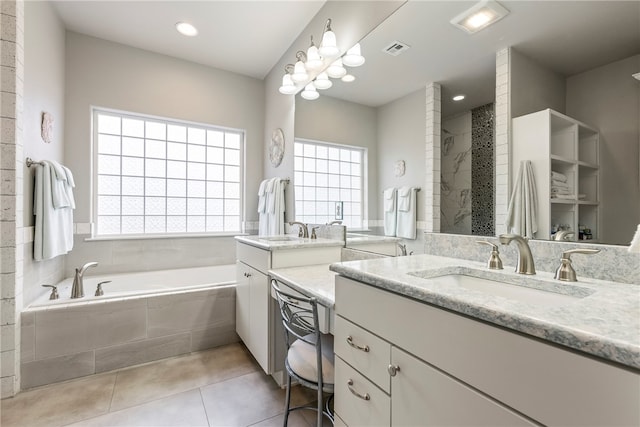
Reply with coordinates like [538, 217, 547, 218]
[511, 109, 600, 242]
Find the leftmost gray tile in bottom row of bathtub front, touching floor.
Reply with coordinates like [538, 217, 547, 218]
[21, 351, 95, 389]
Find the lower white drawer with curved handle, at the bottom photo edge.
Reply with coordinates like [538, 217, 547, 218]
[334, 357, 391, 427]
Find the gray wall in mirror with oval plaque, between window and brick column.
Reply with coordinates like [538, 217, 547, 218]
[373, 89, 427, 224]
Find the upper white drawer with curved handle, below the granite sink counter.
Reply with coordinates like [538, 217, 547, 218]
[333, 316, 391, 393]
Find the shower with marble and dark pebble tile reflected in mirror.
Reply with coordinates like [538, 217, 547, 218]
[440, 103, 495, 236]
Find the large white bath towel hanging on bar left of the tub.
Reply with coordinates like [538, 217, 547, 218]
[33, 161, 73, 261]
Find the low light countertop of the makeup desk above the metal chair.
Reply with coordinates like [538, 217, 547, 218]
[269, 264, 336, 308]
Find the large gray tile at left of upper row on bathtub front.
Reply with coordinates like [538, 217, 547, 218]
[35, 299, 146, 359]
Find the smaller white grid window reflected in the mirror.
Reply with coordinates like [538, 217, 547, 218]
[294, 140, 365, 228]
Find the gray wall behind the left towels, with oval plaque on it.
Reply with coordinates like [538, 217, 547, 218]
[23, 1, 65, 306]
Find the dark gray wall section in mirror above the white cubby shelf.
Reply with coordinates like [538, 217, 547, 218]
[511, 49, 566, 117]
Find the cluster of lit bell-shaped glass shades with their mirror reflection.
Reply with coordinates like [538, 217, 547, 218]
[279, 19, 365, 100]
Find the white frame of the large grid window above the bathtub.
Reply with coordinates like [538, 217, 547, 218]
[90, 105, 247, 240]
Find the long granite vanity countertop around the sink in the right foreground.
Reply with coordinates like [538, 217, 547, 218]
[330, 255, 640, 369]
